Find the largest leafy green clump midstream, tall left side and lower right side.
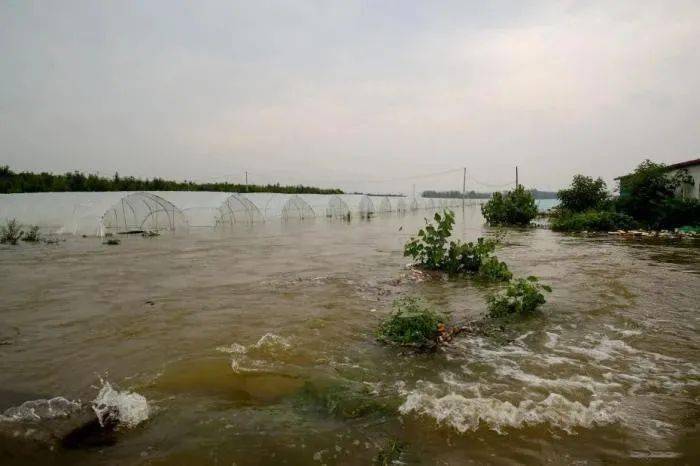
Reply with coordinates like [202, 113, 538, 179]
[404, 210, 512, 281]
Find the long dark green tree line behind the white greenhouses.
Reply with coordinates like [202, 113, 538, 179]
[0, 165, 343, 194]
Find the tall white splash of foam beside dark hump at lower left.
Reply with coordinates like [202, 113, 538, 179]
[92, 380, 151, 428]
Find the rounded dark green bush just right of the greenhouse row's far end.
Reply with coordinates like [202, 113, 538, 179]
[481, 186, 537, 226]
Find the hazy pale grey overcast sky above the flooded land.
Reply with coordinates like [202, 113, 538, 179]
[0, 0, 700, 194]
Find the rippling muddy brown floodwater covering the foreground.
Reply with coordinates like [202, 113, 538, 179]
[0, 207, 700, 465]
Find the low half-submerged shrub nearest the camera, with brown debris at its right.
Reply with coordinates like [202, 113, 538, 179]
[377, 297, 446, 347]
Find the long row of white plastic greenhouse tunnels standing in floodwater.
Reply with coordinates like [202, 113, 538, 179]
[0, 191, 482, 235]
